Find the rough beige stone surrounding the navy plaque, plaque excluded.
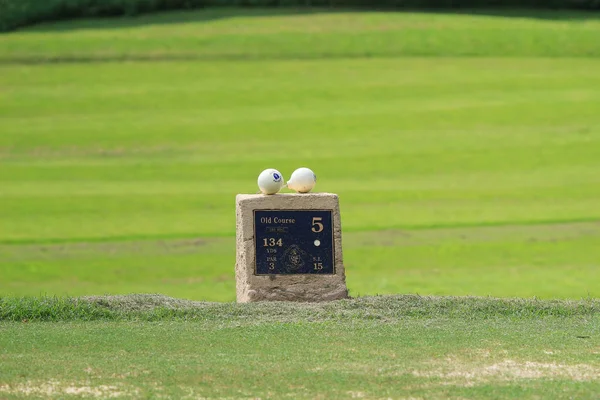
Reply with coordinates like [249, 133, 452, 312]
[235, 193, 348, 303]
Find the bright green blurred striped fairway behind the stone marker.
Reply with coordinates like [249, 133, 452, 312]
[0, 10, 600, 301]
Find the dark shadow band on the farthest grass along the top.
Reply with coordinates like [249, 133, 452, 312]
[19, 7, 600, 32]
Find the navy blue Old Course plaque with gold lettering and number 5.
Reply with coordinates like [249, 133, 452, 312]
[254, 210, 335, 275]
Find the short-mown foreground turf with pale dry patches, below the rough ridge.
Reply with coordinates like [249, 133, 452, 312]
[0, 318, 600, 399]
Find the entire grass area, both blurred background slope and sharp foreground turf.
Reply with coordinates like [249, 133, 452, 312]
[0, 10, 600, 399]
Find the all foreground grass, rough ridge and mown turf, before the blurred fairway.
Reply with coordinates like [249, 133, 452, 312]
[0, 296, 600, 399]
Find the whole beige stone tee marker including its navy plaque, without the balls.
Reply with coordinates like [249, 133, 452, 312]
[235, 193, 348, 303]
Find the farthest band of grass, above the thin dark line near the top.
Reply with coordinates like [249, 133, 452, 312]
[0, 8, 600, 64]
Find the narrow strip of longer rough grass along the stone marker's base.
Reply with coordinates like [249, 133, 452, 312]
[0, 295, 600, 324]
